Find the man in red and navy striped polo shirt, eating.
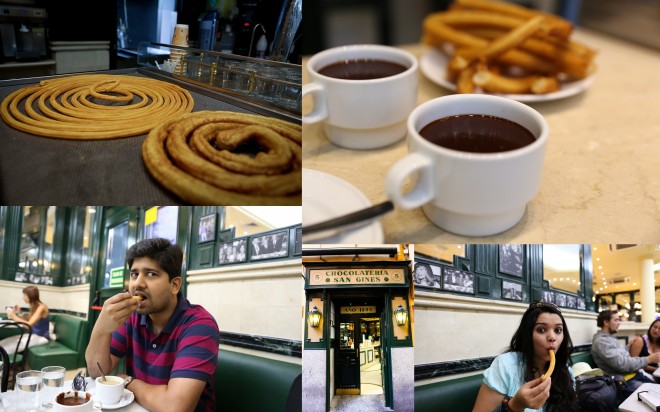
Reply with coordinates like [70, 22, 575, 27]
[85, 239, 220, 412]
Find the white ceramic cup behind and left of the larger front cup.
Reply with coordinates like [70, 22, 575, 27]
[302, 44, 419, 149]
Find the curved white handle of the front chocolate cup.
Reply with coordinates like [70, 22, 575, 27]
[385, 153, 435, 209]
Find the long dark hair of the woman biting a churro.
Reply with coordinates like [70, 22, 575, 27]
[507, 302, 578, 412]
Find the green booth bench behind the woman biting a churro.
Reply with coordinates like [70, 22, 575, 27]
[415, 352, 597, 412]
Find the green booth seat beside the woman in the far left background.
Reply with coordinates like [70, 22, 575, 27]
[28, 315, 87, 370]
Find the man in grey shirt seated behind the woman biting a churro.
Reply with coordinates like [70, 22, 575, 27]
[591, 310, 660, 397]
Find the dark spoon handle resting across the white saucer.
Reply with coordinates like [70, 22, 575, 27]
[303, 200, 394, 242]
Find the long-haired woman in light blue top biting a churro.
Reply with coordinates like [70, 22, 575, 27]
[474, 302, 578, 412]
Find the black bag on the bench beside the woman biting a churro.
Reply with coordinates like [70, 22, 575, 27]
[575, 375, 621, 412]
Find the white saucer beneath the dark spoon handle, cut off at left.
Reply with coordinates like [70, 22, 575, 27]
[303, 168, 383, 244]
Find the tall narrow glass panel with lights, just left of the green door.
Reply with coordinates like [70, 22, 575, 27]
[66, 206, 97, 286]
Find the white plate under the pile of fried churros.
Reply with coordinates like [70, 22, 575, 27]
[419, 49, 594, 103]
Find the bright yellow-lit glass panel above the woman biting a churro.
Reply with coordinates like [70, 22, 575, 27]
[543, 245, 582, 294]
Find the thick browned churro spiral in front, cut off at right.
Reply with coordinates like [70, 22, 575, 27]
[142, 111, 302, 205]
